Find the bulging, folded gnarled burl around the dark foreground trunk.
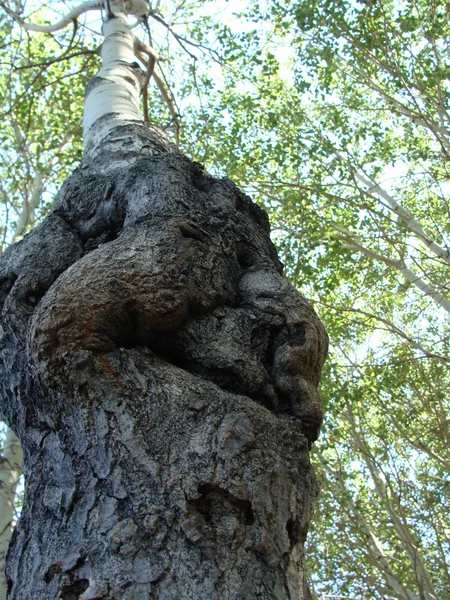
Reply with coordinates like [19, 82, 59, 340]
[0, 155, 327, 441]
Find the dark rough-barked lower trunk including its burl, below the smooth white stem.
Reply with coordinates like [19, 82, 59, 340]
[0, 132, 327, 600]
